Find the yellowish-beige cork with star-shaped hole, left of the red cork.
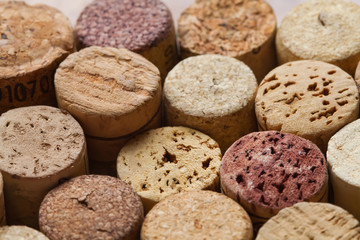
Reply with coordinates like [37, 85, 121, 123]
[117, 127, 221, 212]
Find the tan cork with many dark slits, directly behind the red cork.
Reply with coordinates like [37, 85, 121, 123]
[255, 60, 359, 152]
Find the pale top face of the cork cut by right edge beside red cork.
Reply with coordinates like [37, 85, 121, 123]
[327, 120, 360, 187]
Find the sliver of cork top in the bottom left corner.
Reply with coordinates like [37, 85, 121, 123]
[0, 226, 49, 240]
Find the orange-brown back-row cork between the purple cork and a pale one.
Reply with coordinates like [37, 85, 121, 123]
[178, 0, 277, 82]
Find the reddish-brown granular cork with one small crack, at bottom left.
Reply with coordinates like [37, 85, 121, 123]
[39, 175, 144, 240]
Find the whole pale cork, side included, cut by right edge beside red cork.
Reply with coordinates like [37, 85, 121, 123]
[327, 120, 360, 220]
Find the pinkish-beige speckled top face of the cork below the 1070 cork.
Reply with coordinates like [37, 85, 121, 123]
[0, 106, 85, 178]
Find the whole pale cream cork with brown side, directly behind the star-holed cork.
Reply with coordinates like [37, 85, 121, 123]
[164, 55, 257, 152]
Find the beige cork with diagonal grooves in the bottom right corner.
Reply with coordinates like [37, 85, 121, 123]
[256, 202, 360, 240]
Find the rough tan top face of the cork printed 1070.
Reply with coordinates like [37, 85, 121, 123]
[0, 1, 74, 78]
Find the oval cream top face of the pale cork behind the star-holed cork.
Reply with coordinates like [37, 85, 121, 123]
[164, 55, 257, 117]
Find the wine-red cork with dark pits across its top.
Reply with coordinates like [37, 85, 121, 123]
[220, 131, 328, 218]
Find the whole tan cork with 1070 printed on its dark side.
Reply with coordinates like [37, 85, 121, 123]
[0, 1, 74, 114]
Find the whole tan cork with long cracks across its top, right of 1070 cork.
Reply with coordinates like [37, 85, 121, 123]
[55, 46, 162, 172]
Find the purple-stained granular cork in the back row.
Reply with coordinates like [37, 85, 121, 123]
[75, 0, 178, 79]
